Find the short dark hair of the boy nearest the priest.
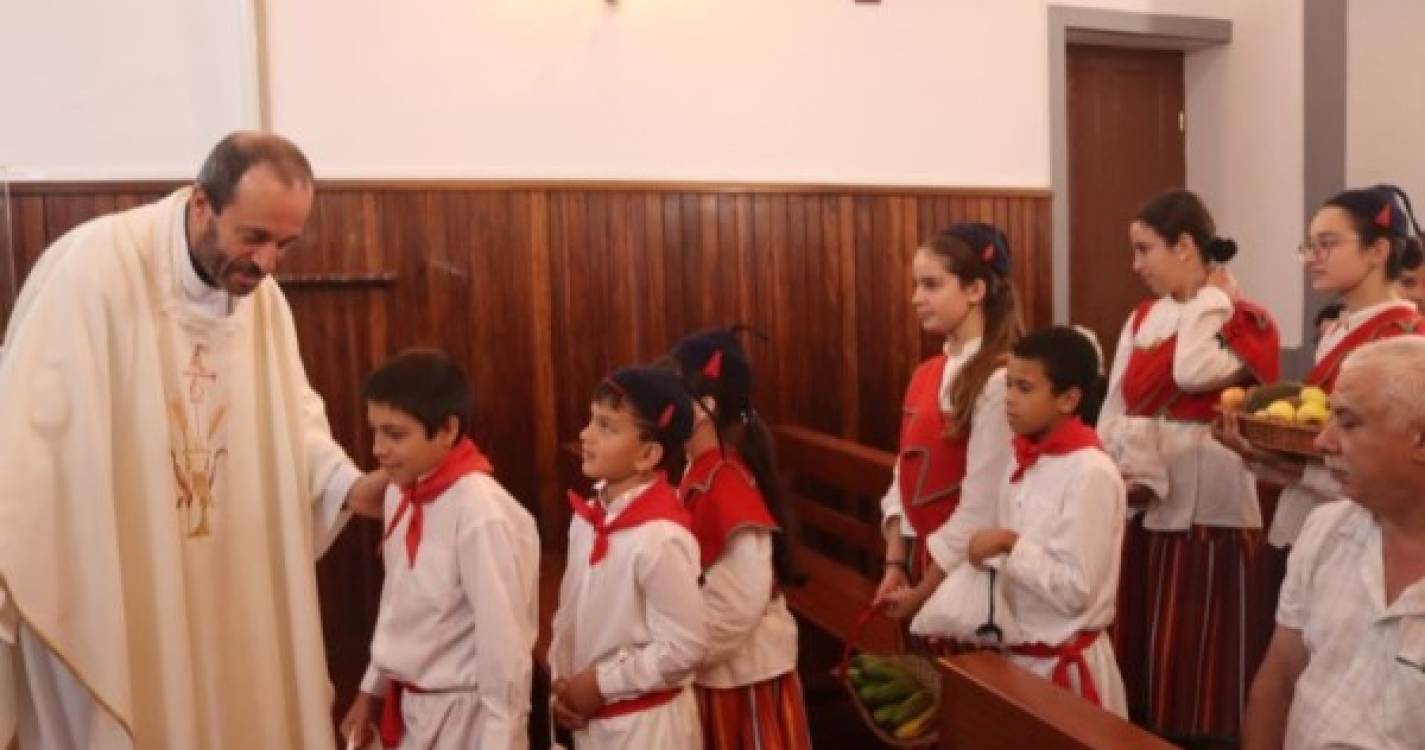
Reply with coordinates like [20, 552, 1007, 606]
[362, 349, 475, 438]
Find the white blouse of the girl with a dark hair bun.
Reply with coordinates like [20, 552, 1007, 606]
[1099, 287, 1261, 530]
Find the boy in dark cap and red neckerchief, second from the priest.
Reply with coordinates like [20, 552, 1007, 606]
[549, 366, 707, 750]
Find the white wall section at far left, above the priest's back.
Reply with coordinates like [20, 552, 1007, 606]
[0, 0, 257, 180]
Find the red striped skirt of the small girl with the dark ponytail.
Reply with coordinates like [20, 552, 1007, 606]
[697, 670, 811, 750]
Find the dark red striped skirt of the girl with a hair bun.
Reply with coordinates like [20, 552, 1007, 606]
[1113, 519, 1275, 741]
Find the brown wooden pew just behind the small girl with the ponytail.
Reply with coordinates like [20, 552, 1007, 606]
[772, 425, 901, 653]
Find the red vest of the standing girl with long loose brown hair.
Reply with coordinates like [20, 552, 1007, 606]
[898, 354, 968, 539]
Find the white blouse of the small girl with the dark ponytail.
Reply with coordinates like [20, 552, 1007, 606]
[695, 528, 797, 689]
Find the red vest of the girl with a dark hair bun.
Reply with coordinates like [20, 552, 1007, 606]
[1123, 299, 1281, 422]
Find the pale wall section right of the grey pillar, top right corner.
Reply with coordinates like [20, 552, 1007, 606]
[1345, 0, 1425, 211]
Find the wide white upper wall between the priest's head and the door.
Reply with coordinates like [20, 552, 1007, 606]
[268, 0, 1254, 187]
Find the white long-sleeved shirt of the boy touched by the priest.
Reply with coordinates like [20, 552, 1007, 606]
[362, 472, 539, 747]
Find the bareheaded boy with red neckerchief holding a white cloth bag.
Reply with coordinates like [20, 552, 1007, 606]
[909, 327, 1127, 717]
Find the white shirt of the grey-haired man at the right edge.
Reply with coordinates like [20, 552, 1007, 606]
[1277, 500, 1425, 750]
